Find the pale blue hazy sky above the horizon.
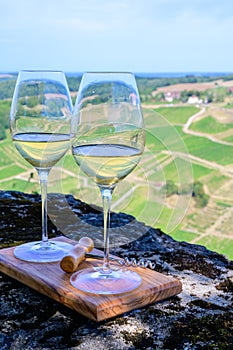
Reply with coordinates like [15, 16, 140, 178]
[0, 0, 233, 73]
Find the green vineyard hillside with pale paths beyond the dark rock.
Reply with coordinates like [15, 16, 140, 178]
[0, 74, 233, 259]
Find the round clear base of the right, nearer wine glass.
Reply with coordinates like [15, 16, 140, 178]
[70, 267, 142, 294]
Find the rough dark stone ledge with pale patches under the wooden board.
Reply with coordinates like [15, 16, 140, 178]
[0, 192, 233, 350]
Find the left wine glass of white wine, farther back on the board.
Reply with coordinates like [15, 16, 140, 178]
[10, 71, 72, 262]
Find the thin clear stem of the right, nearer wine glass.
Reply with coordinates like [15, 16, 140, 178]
[100, 188, 112, 272]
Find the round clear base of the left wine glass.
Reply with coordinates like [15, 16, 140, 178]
[14, 241, 73, 263]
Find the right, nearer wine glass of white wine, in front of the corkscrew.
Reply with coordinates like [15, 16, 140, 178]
[70, 72, 145, 294]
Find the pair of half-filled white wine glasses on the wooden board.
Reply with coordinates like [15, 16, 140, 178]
[11, 72, 145, 294]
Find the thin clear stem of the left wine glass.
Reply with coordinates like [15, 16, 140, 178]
[37, 169, 50, 246]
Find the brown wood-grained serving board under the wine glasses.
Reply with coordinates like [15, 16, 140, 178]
[0, 237, 182, 321]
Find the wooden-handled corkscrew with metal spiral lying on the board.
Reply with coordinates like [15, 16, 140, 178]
[60, 237, 155, 273]
